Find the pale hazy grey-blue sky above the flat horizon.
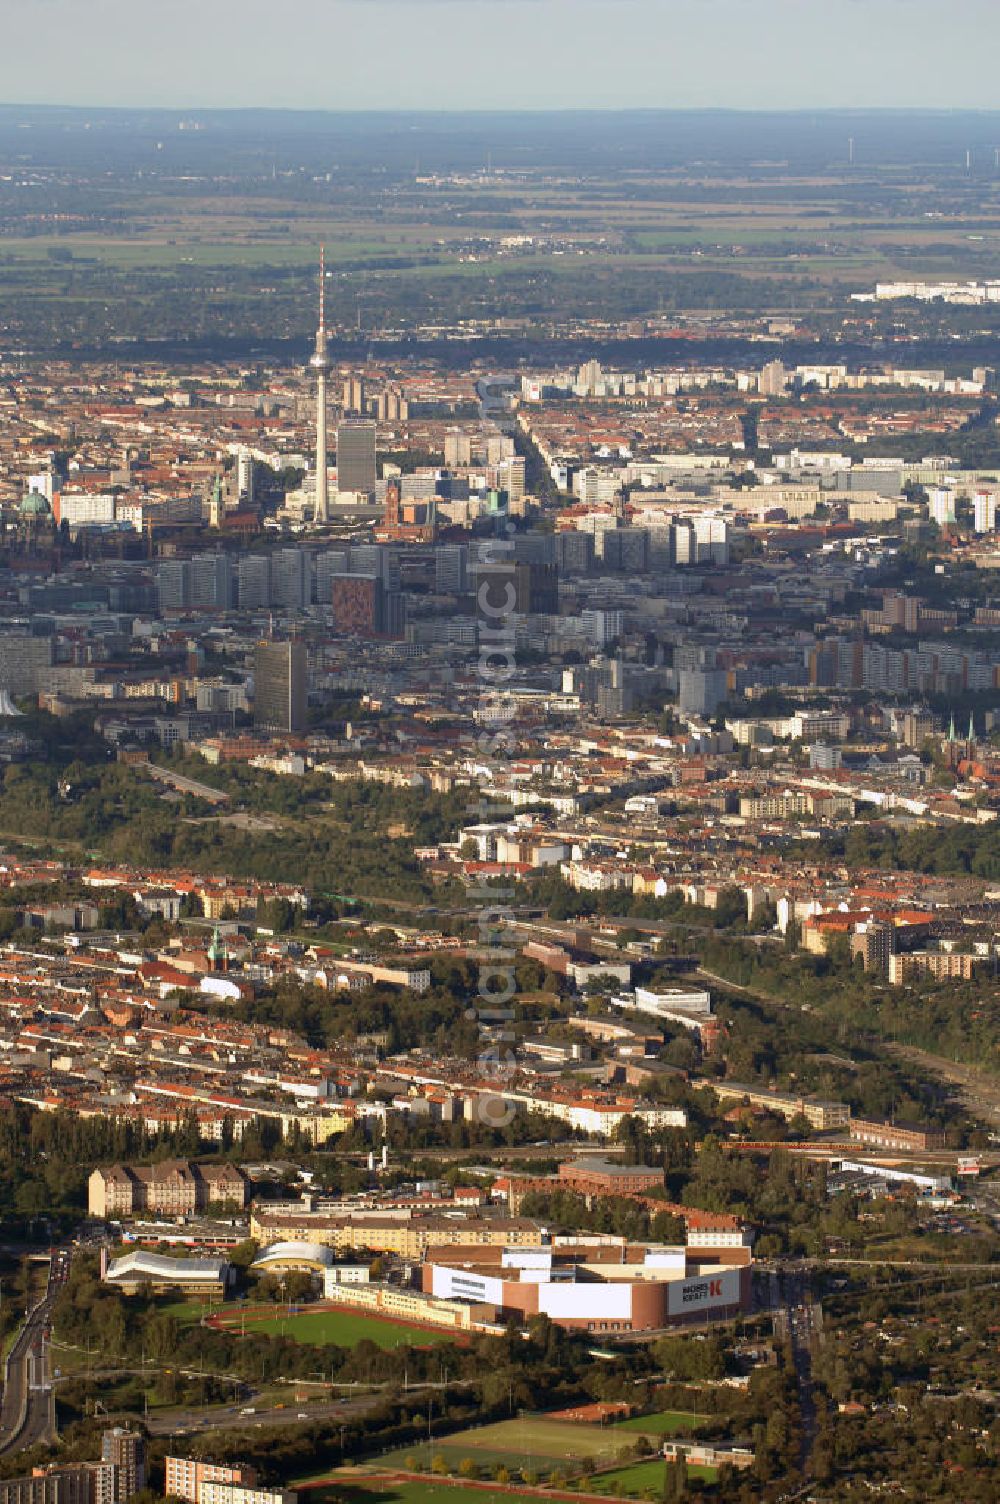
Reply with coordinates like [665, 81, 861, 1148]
[7, 0, 1000, 108]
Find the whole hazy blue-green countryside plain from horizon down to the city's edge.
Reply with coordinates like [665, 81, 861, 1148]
[0, 107, 1000, 348]
